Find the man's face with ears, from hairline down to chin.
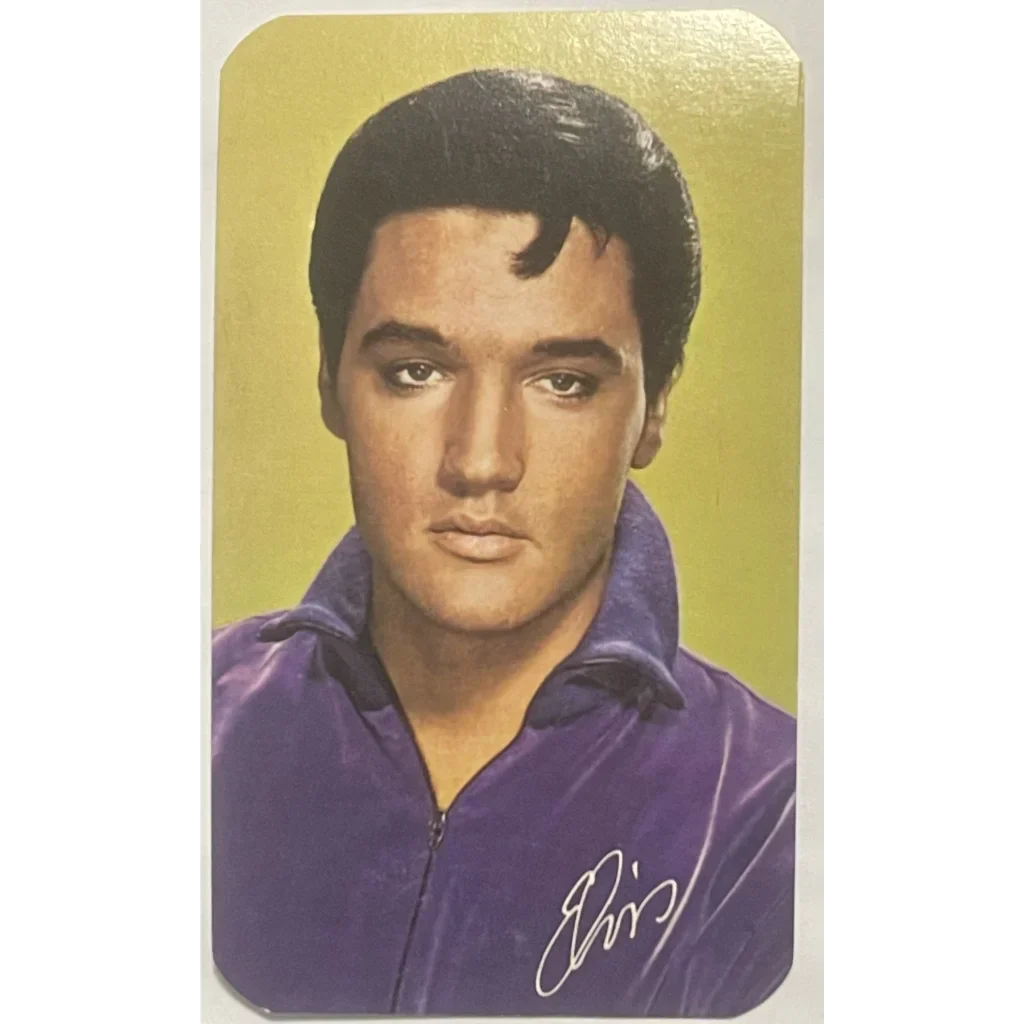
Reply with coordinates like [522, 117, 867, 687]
[322, 208, 664, 632]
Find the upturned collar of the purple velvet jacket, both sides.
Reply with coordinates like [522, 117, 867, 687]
[259, 481, 683, 717]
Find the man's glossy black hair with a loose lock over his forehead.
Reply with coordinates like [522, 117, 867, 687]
[309, 70, 700, 400]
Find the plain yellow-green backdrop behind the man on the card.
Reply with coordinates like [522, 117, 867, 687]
[212, 11, 803, 711]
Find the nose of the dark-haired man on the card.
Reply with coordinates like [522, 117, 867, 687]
[440, 379, 524, 498]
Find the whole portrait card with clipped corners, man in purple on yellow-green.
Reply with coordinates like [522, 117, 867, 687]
[203, 9, 823, 1024]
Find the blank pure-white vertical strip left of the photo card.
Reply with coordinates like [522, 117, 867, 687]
[0, 0, 201, 1024]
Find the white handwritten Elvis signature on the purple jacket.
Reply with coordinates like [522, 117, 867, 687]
[535, 850, 679, 998]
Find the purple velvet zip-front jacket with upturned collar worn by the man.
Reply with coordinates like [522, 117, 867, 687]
[212, 484, 796, 1017]
